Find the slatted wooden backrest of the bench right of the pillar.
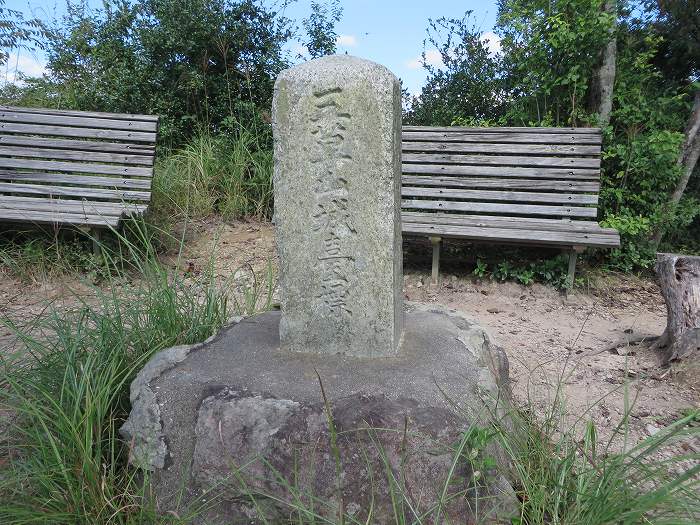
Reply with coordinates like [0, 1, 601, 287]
[402, 126, 601, 221]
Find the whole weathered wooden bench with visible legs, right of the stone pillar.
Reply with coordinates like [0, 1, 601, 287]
[401, 126, 620, 285]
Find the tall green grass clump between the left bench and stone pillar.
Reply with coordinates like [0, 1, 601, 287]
[152, 127, 272, 219]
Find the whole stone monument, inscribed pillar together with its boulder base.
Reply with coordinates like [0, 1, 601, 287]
[121, 56, 517, 525]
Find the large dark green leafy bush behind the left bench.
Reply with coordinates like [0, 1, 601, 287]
[36, 0, 292, 144]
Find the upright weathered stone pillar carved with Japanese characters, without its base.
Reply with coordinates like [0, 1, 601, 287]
[272, 55, 403, 357]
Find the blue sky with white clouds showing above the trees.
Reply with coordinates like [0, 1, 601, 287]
[3, 0, 498, 93]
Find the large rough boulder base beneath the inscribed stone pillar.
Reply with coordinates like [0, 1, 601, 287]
[122, 305, 517, 524]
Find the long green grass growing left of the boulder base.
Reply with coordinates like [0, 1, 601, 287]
[0, 223, 276, 524]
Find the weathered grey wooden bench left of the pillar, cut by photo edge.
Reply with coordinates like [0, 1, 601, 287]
[0, 106, 158, 244]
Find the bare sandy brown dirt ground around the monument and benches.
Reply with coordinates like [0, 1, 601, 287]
[0, 217, 700, 451]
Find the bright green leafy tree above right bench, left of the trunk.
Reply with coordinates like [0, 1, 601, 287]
[496, 0, 615, 126]
